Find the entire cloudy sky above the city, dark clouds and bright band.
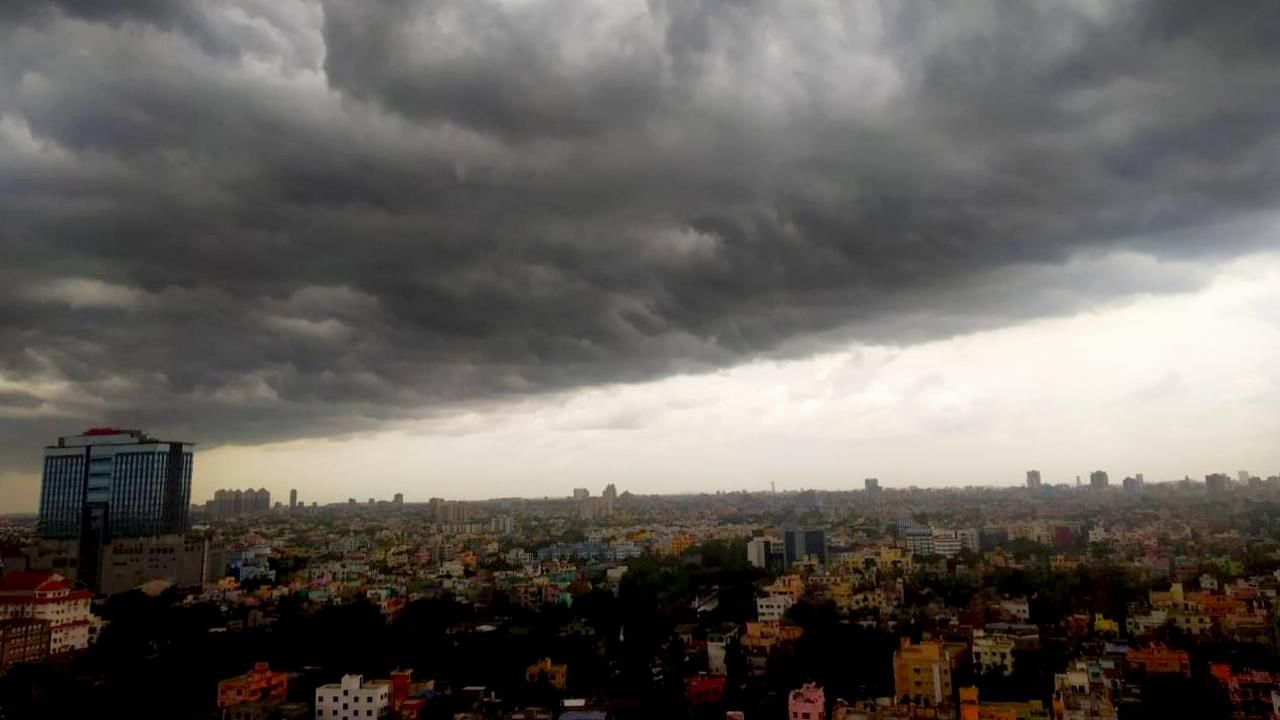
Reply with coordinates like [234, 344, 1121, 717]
[0, 0, 1280, 511]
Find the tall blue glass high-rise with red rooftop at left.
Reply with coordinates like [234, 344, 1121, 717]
[38, 428, 195, 589]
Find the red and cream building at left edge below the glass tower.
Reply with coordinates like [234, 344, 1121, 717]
[0, 570, 93, 655]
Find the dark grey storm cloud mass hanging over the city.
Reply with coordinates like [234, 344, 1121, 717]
[0, 0, 1280, 465]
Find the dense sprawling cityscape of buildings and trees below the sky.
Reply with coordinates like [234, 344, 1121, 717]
[0, 428, 1280, 720]
